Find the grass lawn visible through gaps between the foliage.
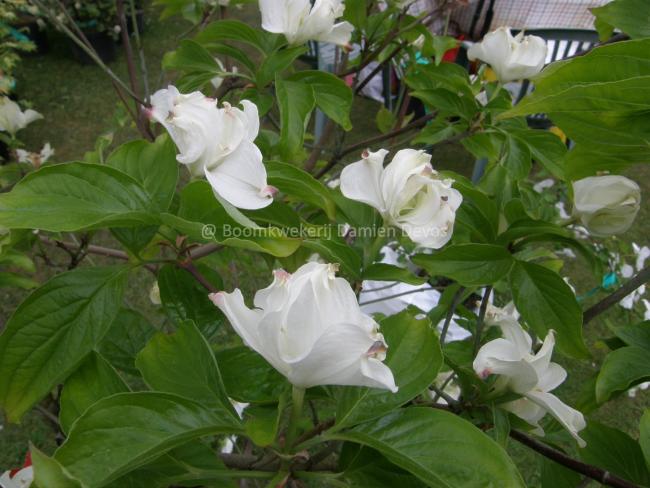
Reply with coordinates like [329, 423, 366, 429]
[0, 1, 650, 485]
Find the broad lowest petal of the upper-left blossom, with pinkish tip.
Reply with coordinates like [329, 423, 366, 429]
[205, 141, 275, 210]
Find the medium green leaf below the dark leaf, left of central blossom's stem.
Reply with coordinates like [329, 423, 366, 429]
[135, 320, 236, 418]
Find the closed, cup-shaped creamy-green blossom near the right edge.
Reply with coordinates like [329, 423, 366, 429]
[573, 175, 641, 237]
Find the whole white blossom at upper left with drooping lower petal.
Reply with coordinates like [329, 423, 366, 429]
[149, 86, 277, 210]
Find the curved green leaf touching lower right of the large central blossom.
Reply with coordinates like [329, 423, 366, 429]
[336, 311, 442, 428]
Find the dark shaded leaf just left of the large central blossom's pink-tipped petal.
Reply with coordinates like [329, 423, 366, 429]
[158, 264, 225, 340]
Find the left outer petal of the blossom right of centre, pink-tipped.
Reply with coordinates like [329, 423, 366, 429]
[341, 149, 388, 212]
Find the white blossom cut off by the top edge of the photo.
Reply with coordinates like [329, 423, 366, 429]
[260, 0, 354, 46]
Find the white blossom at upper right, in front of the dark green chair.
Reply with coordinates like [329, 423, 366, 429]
[467, 27, 547, 83]
